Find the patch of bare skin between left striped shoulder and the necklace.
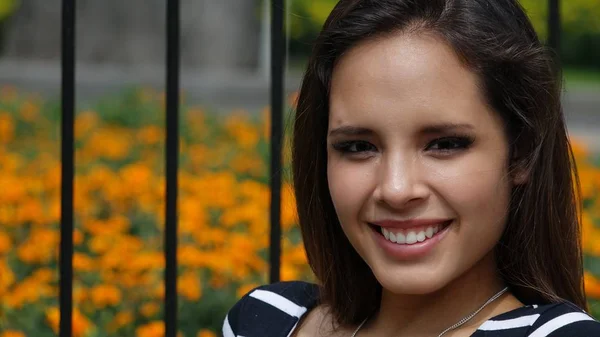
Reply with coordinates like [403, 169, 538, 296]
[291, 305, 352, 337]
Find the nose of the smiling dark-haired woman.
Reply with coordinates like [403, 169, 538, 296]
[374, 155, 430, 209]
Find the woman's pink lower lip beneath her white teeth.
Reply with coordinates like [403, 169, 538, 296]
[373, 222, 453, 260]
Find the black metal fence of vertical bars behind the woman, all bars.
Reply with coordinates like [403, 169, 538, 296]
[59, 0, 560, 337]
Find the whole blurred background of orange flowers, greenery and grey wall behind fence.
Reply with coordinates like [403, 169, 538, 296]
[0, 0, 600, 337]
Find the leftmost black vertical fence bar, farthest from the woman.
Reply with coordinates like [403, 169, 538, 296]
[59, 0, 75, 337]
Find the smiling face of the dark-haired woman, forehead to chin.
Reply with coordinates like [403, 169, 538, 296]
[327, 34, 513, 294]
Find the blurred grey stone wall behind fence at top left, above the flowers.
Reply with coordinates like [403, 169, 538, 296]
[2, 0, 261, 70]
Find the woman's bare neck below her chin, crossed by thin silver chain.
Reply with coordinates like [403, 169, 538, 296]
[364, 256, 522, 337]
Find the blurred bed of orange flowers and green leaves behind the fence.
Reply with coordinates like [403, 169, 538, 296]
[0, 87, 600, 337]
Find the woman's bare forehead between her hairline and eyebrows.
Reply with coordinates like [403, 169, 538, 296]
[329, 33, 490, 128]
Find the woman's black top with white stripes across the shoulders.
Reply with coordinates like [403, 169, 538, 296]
[223, 281, 600, 337]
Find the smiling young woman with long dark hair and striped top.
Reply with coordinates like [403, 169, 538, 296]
[223, 0, 600, 337]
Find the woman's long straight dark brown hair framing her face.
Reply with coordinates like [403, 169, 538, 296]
[292, 0, 586, 325]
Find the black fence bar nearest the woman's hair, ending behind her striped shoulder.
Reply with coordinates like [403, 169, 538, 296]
[269, 0, 285, 283]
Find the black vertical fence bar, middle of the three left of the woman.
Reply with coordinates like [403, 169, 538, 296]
[164, 0, 179, 337]
